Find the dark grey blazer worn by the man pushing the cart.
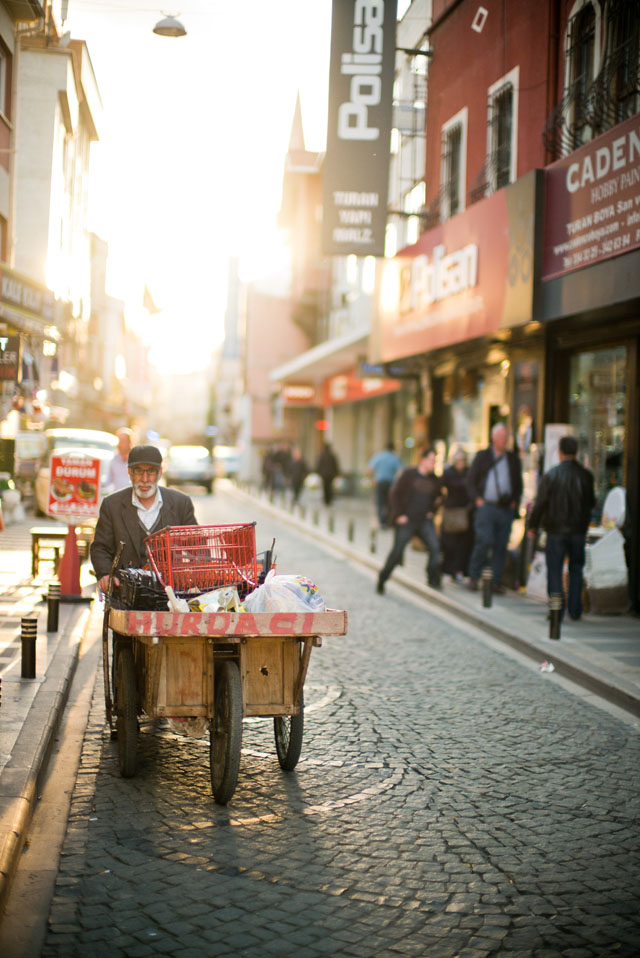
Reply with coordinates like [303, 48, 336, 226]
[90, 486, 198, 579]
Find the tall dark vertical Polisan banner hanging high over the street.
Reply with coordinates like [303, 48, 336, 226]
[322, 0, 397, 256]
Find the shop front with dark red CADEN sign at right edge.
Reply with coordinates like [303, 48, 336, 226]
[539, 114, 640, 611]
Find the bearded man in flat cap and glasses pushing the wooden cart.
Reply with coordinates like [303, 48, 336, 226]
[91, 446, 198, 592]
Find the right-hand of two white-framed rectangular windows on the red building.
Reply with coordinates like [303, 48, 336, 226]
[487, 67, 519, 192]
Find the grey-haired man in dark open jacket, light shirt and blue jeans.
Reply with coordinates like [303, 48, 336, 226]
[467, 423, 522, 595]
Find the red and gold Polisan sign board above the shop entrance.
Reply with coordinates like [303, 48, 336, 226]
[370, 171, 539, 362]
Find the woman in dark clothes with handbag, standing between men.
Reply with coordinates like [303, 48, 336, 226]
[440, 447, 473, 582]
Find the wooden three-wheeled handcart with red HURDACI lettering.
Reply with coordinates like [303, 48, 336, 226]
[109, 609, 347, 805]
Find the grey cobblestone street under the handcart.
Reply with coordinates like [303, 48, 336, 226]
[42, 494, 640, 958]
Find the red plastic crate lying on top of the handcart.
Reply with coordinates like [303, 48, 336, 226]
[144, 522, 258, 594]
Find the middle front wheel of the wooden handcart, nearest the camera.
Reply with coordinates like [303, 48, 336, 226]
[209, 659, 242, 805]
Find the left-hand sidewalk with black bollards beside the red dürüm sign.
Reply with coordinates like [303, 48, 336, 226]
[0, 516, 99, 916]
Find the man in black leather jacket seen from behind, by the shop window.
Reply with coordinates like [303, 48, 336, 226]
[527, 436, 595, 620]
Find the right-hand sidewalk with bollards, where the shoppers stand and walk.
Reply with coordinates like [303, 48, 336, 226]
[234, 486, 640, 716]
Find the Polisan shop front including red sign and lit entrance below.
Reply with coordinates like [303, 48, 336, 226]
[371, 171, 544, 492]
